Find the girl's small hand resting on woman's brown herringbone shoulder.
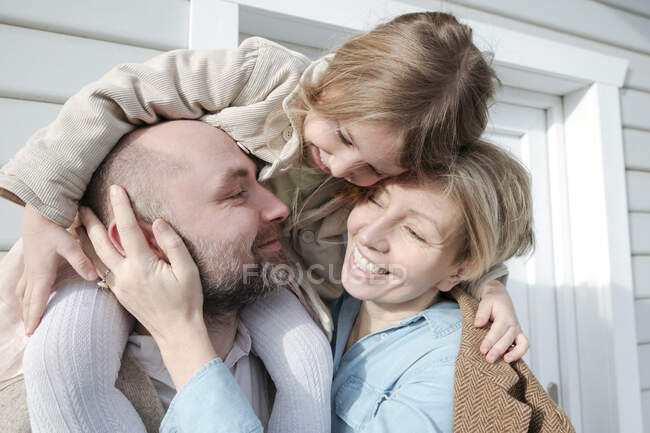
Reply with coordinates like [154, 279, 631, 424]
[474, 280, 530, 363]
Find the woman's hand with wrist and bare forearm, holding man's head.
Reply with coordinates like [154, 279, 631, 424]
[79, 185, 217, 389]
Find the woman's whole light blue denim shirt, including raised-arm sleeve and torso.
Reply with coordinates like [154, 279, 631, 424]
[160, 294, 461, 433]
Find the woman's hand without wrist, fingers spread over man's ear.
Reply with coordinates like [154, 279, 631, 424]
[79, 186, 203, 339]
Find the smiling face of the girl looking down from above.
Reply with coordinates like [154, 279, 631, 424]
[303, 113, 406, 186]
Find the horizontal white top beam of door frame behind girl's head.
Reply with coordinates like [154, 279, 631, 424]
[225, 0, 628, 90]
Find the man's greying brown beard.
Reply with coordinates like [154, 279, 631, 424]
[176, 223, 280, 322]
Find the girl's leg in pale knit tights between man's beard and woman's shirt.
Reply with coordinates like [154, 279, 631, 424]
[241, 288, 332, 433]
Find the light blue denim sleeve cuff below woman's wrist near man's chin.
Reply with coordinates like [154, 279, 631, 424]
[160, 358, 264, 433]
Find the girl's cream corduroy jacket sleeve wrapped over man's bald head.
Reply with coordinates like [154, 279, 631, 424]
[0, 38, 305, 227]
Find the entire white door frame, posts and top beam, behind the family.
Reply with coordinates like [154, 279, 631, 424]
[189, 0, 642, 433]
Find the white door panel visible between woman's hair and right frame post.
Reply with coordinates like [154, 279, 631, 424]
[484, 93, 562, 401]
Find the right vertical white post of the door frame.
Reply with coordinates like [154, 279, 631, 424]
[564, 83, 642, 432]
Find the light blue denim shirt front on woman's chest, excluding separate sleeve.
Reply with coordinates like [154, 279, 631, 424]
[332, 294, 462, 433]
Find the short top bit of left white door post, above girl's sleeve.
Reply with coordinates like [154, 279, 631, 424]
[189, 0, 239, 50]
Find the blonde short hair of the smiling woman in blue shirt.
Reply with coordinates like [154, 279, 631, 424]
[341, 141, 535, 283]
